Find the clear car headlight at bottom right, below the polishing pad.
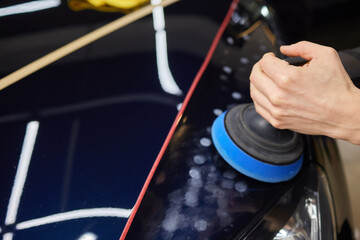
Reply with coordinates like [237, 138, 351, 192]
[246, 165, 336, 240]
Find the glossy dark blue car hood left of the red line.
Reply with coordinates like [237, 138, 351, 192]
[0, 1, 231, 239]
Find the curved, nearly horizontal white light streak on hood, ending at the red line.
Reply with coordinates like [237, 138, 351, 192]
[16, 208, 132, 230]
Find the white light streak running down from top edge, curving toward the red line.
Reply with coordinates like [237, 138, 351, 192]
[151, 0, 182, 95]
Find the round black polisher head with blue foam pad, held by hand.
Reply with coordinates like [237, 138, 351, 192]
[211, 57, 307, 183]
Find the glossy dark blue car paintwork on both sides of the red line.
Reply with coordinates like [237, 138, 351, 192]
[0, 0, 354, 240]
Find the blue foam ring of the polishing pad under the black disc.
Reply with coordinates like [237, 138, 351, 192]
[211, 112, 303, 183]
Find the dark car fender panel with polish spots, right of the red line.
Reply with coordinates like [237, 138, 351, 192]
[126, 0, 351, 239]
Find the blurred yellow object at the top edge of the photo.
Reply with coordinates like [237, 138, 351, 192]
[68, 0, 150, 13]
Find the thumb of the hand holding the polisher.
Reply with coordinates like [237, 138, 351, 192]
[280, 41, 325, 60]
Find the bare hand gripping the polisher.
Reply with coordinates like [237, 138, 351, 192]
[250, 41, 360, 144]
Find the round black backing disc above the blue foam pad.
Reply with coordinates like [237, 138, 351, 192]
[225, 104, 303, 165]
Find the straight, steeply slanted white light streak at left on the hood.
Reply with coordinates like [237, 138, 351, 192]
[5, 121, 39, 224]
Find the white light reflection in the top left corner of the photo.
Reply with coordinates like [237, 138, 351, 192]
[0, 0, 61, 17]
